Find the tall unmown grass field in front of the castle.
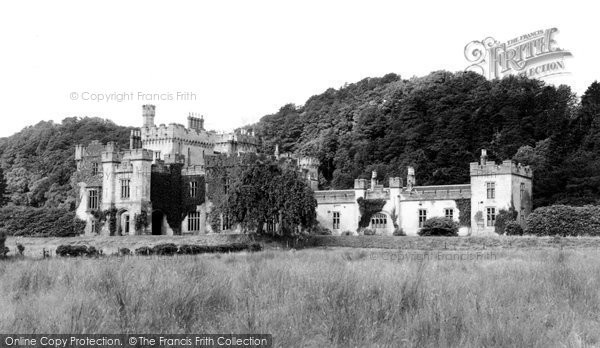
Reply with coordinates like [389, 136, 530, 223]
[0, 248, 600, 347]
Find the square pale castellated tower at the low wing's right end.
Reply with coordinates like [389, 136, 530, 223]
[470, 149, 533, 235]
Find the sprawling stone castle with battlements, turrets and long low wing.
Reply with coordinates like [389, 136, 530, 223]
[75, 105, 532, 235]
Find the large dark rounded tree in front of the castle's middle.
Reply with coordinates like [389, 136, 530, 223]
[225, 159, 317, 235]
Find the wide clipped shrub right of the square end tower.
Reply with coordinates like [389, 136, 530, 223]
[524, 205, 600, 236]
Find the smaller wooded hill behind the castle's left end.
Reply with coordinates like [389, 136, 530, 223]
[0, 117, 131, 209]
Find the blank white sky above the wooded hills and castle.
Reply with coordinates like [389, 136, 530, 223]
[0, 0, 600, 137]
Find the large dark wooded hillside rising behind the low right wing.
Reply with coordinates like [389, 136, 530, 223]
[254, 71, 600, 206]
